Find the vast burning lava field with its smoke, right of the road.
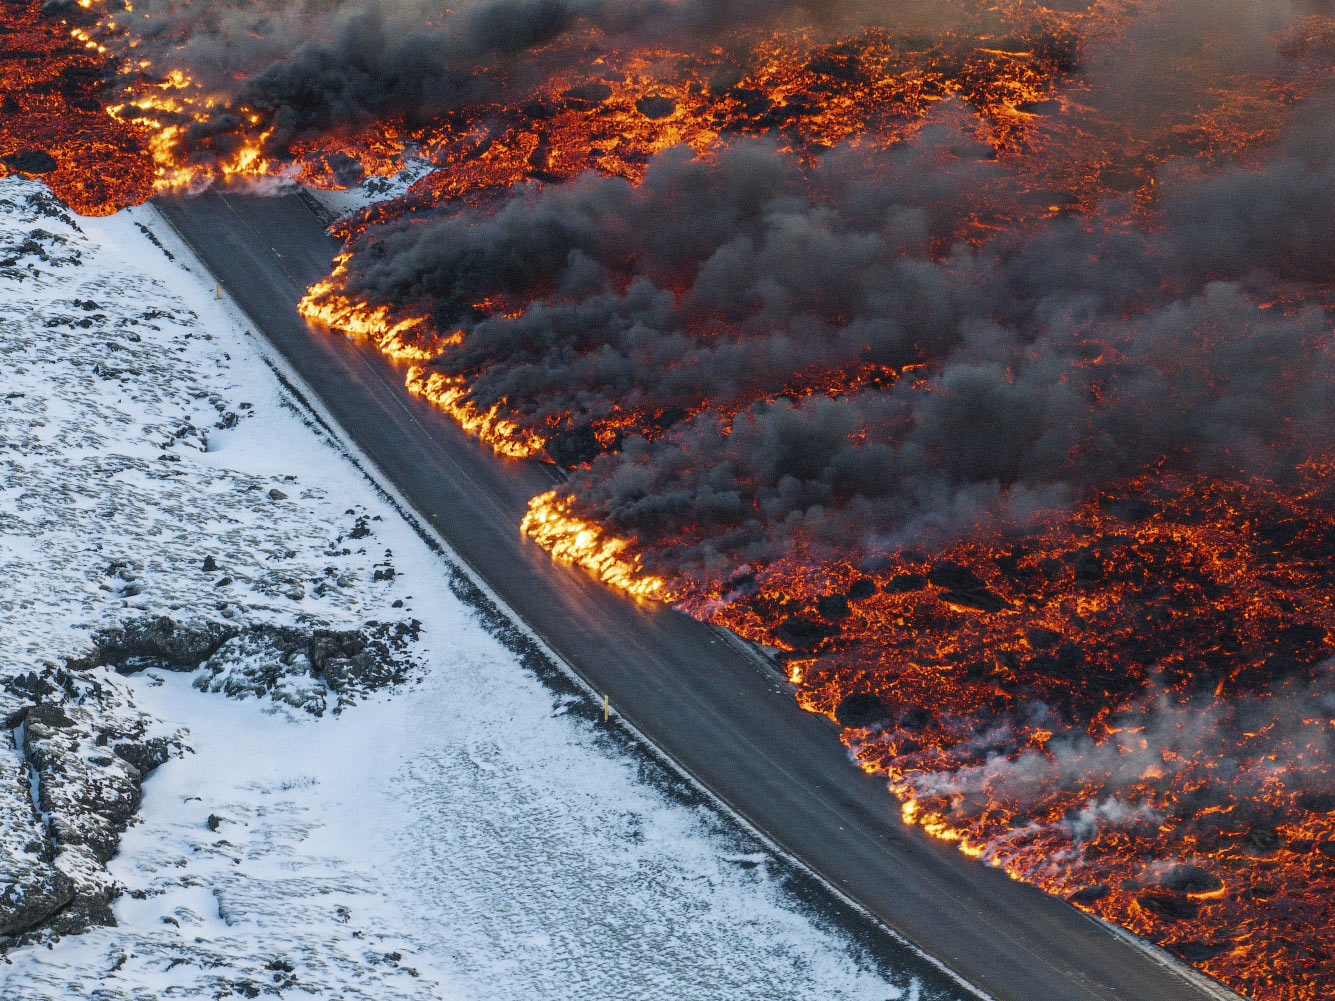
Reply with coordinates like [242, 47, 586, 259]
[7, 0, 1335, 1001]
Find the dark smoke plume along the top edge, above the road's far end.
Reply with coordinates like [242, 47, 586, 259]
[106, 0, 875, 156]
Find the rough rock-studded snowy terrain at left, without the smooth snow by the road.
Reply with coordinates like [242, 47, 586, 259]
[0, 179, 421, 949]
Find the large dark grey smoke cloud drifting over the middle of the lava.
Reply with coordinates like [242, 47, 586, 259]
[333, 102, 1335, 567]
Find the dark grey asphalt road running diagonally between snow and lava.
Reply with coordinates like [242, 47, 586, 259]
[159, 192, 1236, 1001]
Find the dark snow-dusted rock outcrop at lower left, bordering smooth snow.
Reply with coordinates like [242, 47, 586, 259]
[0, 617, 421, 952]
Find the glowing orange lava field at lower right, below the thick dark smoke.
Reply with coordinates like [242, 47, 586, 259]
[699, 480, 1335, 998]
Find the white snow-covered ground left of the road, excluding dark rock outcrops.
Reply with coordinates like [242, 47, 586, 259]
[0, 179, 966, 1001]
